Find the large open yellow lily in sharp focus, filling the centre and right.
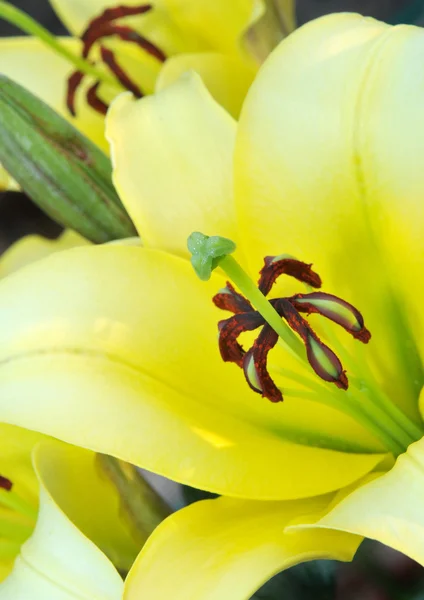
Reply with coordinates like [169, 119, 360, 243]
[0, 15, 424, 600]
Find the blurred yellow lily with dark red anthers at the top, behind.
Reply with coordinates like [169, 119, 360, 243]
[0, 0, 295, 171]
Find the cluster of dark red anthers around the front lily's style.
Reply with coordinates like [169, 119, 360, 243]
[213, 256, 371, 402]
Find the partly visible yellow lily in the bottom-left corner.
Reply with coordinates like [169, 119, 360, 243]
[0, 424, 139, 600]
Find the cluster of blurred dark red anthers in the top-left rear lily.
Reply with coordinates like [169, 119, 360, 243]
[66, 4, 166, 116]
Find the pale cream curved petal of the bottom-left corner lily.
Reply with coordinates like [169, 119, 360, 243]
[0, 443, 123, 600]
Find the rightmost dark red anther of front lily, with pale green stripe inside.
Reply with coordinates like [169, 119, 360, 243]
[289, 292, 371, 344]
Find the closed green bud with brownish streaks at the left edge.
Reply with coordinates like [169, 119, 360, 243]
[0, 76, 135, 243]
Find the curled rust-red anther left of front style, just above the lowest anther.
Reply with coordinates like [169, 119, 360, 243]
[218, 311, 265, 367]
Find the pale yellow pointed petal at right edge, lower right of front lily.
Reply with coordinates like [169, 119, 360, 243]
[304, 440, 424, 565]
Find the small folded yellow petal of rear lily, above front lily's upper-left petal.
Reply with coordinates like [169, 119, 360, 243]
[156, 52, 255, 119]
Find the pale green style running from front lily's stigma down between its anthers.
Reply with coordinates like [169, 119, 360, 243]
[219, 255, 304, 358]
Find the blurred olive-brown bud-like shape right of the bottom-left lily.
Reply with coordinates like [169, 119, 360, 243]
[97, 454, 172, 543]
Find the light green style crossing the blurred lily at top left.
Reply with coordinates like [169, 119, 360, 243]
[0, 0, 119, 87]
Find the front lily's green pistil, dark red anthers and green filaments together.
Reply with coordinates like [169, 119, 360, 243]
[188, 232, 424, 456]
